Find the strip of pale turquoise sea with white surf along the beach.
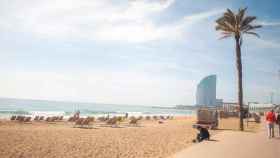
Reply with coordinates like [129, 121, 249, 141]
[0, 98, 195, 119]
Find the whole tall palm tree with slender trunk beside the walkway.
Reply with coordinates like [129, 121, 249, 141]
[216, 8, 262, 131]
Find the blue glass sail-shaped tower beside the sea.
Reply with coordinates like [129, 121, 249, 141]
[196, 75, 223, 106]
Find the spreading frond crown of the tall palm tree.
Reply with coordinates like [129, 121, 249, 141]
[216, 8, 262, 39]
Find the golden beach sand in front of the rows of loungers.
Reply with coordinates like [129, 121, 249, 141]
[0, 117, 257, 158]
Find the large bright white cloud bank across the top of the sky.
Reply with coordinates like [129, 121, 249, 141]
[0, 0, 221, 43]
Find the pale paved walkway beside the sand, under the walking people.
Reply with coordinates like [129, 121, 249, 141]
[172, 123, 280, 158]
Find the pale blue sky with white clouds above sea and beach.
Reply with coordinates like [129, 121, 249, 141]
[0, 0, 280, 106]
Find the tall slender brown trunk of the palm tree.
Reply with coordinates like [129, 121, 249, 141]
[235, 36, 244, 131]
